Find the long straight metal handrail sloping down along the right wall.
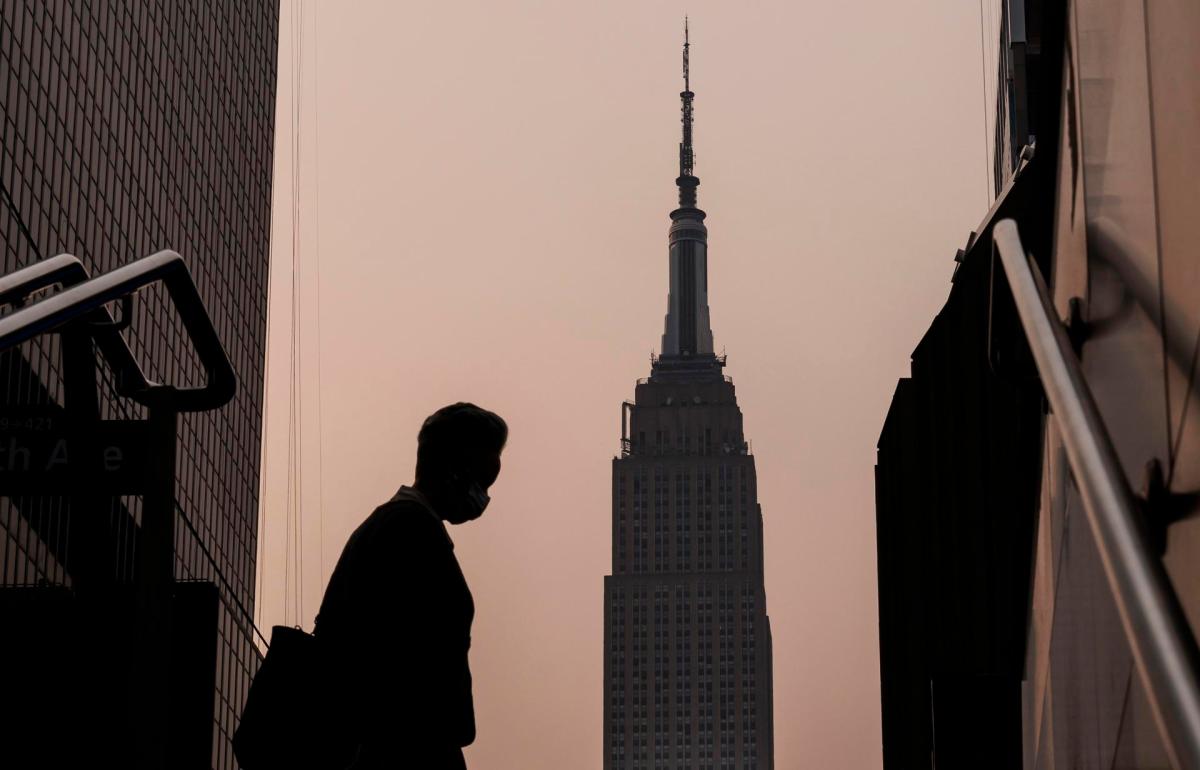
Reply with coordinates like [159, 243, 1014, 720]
[992, 219, 1200, 770]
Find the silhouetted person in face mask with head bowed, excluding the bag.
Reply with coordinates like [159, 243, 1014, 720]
[316, 403, 508, 770]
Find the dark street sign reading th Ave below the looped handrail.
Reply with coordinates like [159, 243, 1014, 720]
[0, 409, 151, 497]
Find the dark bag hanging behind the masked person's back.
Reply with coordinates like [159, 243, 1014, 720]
[233, 626, 359, 770]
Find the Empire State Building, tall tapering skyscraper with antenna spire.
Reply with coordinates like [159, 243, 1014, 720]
[604, 26, 774, 770]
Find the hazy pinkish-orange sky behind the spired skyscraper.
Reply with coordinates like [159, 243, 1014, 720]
[258, 0, 996, 770]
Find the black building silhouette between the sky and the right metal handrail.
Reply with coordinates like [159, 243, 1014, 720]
[876, 0, 1062, 770]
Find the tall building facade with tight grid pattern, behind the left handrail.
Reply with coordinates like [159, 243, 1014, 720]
[0, 0, 278, 768]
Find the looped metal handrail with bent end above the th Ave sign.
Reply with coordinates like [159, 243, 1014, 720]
[0, 251, 238, 411]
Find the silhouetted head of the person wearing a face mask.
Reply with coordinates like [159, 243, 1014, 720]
[416, 402, 509, 524]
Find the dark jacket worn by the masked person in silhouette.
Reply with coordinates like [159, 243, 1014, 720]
[314, 487, 475, 756]
